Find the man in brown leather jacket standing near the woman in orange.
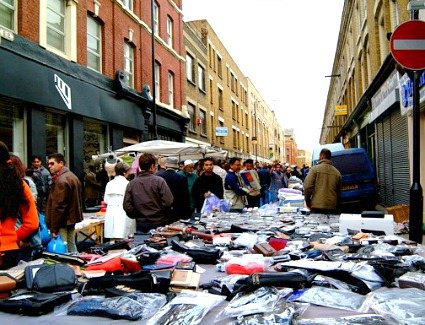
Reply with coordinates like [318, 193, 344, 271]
[46, 153, 83, 252]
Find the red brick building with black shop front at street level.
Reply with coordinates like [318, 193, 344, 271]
[0, 0, 188, 177]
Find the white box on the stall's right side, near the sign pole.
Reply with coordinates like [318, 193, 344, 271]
[339, 213, 394, 235]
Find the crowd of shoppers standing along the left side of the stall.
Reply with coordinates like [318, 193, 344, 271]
[0, 137, 322, 269]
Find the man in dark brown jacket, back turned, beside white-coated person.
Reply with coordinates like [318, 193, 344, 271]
[123, 153, 173, 233]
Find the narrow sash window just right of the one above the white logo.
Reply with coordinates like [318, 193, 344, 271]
[87, 16, 102, 72]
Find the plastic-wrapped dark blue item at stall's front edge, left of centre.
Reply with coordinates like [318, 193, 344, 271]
[67, 293, 167, 320]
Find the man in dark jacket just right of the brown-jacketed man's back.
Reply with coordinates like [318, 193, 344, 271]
[157, 157, 192, 221]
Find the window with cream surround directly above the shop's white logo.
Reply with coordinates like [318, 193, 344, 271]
[47, 0, 65, 52]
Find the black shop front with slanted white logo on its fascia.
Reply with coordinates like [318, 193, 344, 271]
[0, 35, 187, 179]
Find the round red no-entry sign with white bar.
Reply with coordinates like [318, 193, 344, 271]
[390, 20, 425, 70]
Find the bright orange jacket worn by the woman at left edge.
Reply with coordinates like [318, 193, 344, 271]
[0, 181, 38, 252]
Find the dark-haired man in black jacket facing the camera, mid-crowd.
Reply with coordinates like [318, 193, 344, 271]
[192, 158, 224, 212]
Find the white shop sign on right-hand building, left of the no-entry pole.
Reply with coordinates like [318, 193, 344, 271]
[370, 70, 399, 122]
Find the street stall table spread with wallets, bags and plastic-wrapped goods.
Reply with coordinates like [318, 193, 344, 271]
[0, 206, 425, 324]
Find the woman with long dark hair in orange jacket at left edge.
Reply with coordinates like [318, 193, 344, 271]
[0, 141, 38, 270]
